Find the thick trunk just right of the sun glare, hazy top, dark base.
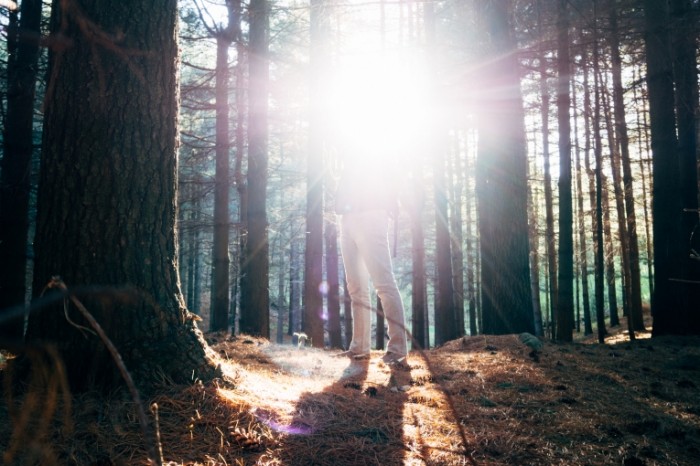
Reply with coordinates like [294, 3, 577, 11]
[477, 1, 534, 334]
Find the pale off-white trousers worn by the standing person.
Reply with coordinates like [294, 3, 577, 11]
[340, 210, 407, 356]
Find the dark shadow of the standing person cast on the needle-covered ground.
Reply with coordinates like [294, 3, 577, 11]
[281, 357, 411, 466]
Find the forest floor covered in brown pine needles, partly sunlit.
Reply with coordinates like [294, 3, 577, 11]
[0, 318, 700, 466]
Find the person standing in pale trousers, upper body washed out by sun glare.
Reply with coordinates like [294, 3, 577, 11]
[335, 144, 408, 365]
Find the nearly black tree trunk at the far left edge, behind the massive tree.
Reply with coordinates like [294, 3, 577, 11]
[0, 0, 41, 339]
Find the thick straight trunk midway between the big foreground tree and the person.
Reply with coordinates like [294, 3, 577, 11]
[240, 0, 270, 338]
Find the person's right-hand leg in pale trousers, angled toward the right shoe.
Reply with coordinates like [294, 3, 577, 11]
[356, 210, 408, 356]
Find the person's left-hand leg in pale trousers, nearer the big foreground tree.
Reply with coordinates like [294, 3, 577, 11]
[340, 214, 371, 355]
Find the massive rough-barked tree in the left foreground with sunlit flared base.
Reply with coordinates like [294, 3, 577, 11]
[27, 0, 220, 390]
